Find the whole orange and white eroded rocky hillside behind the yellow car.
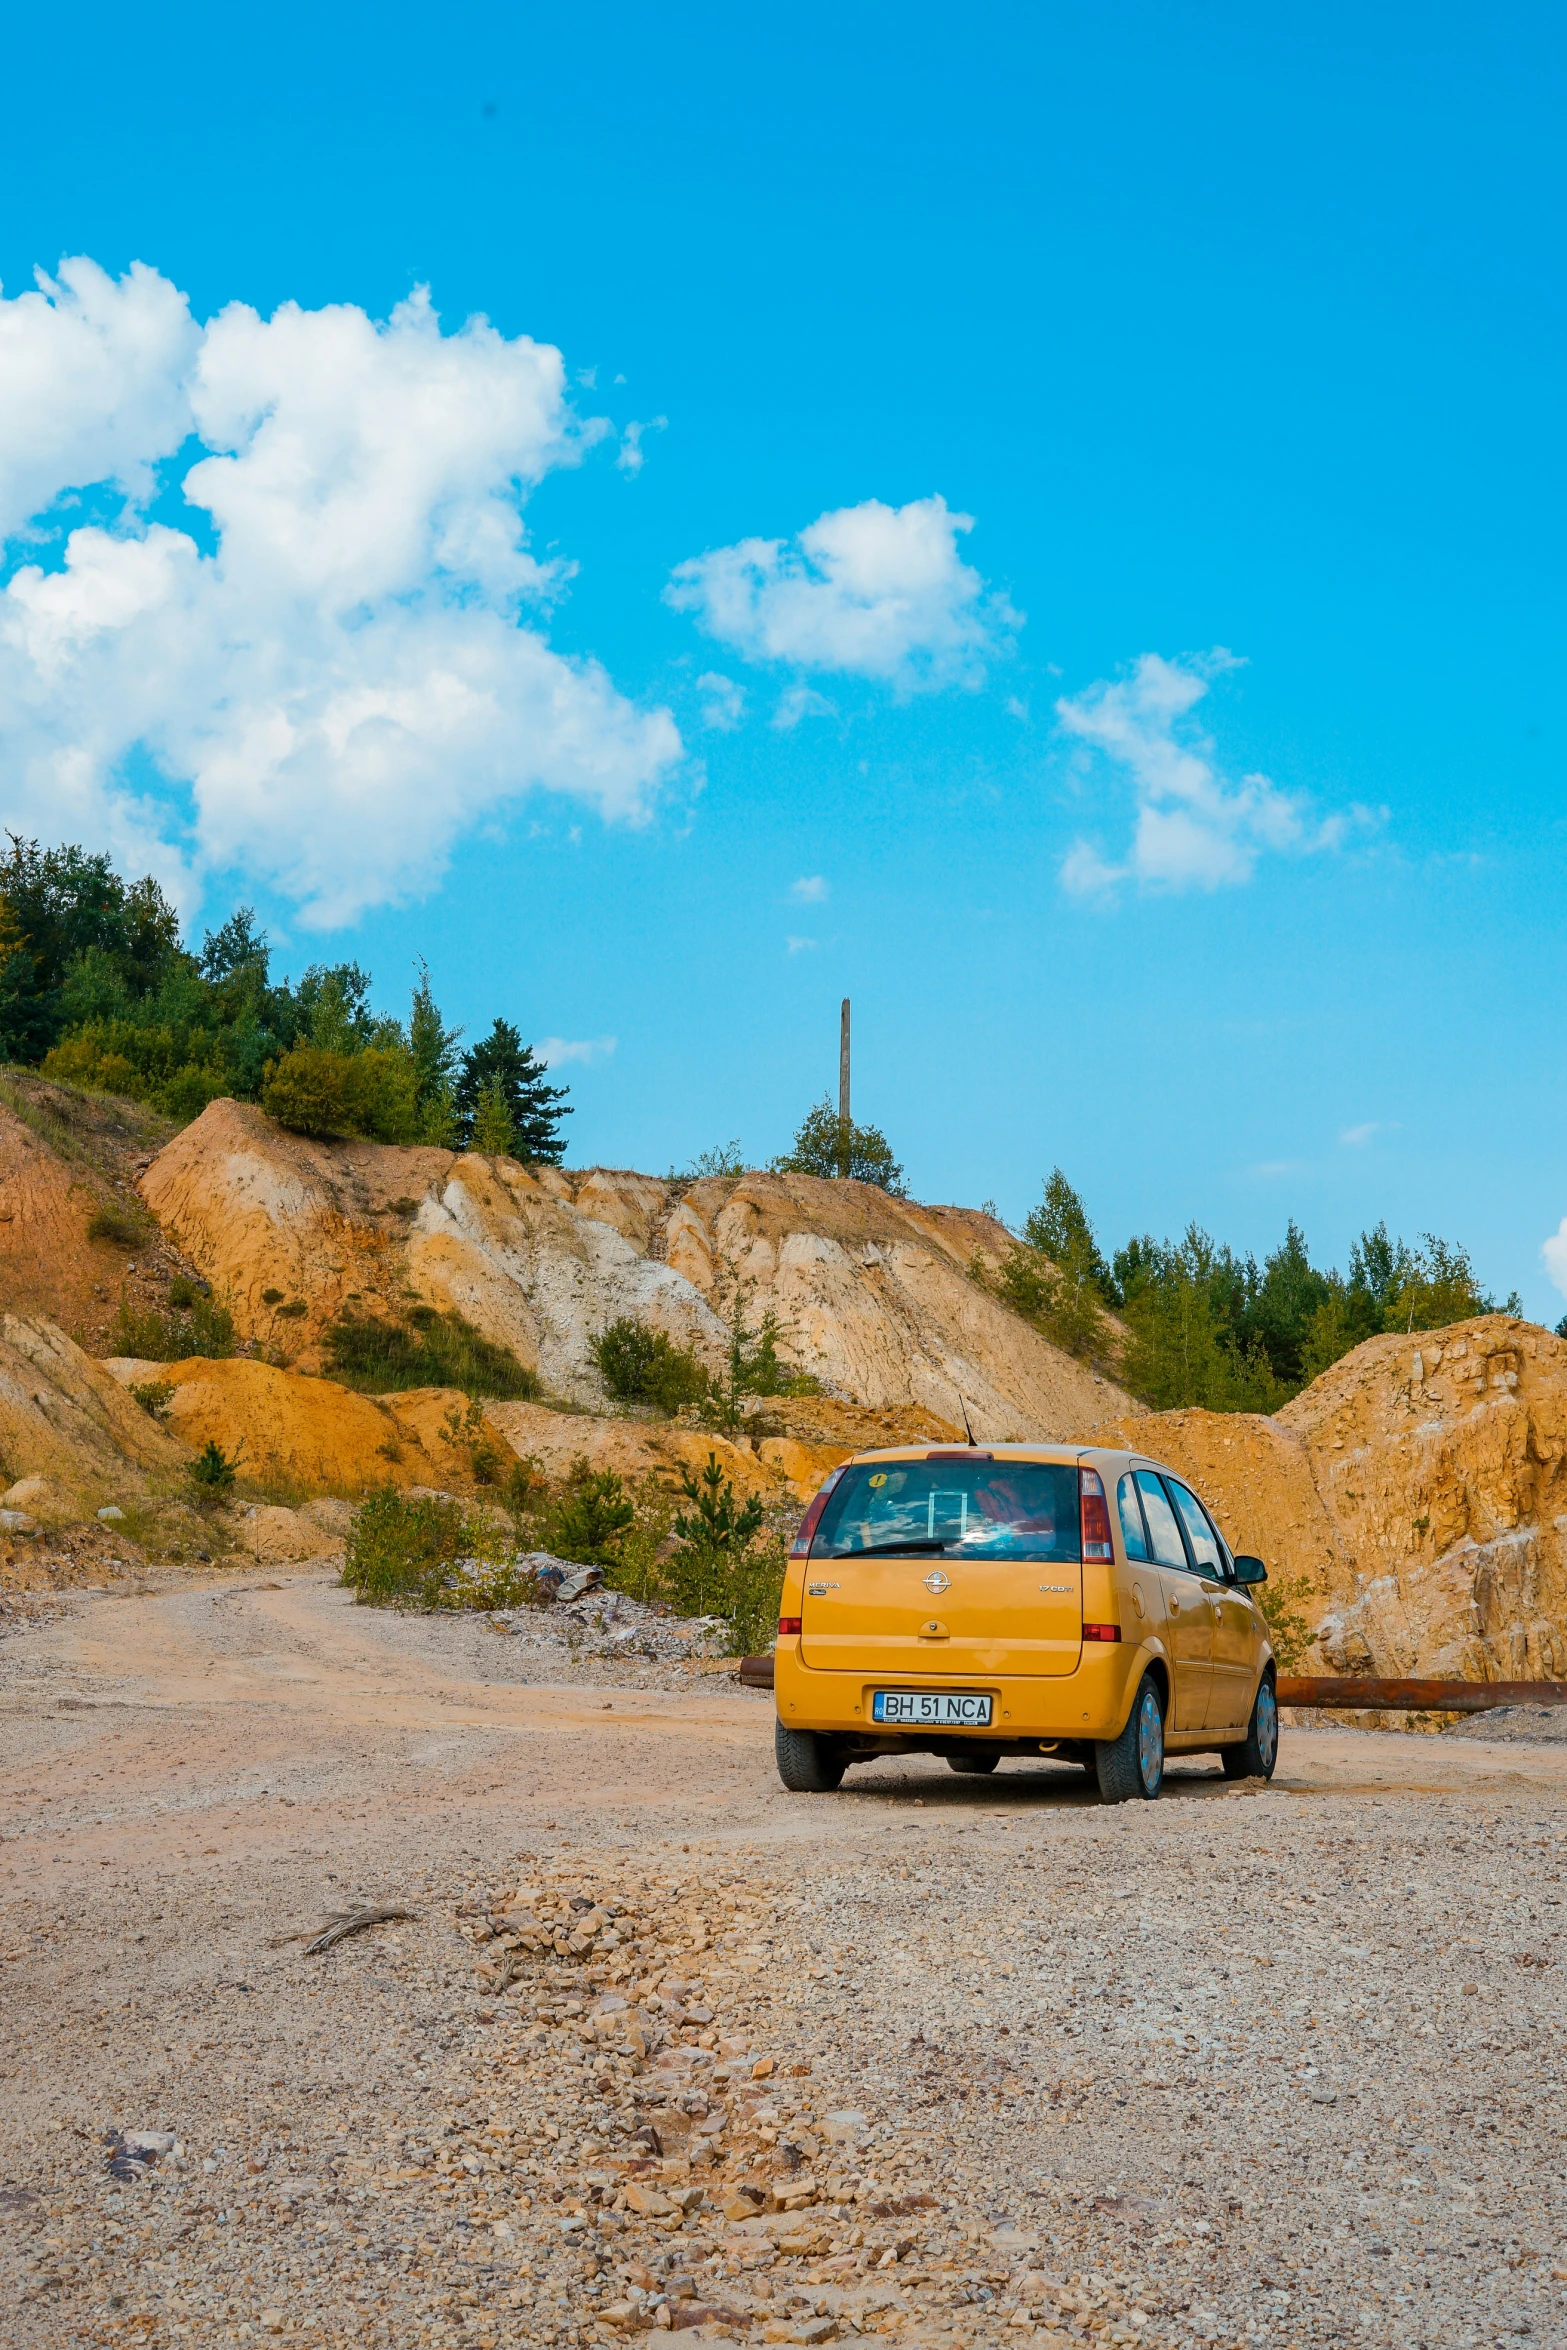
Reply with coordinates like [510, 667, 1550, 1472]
[0, 1097, 1567, 1680]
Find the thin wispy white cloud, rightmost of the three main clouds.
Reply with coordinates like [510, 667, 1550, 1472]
[1055, 649, 1370, 898]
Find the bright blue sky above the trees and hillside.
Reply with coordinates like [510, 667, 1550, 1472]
[0, 5, 1567, 1321]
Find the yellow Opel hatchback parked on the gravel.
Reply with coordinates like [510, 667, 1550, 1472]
[773, 1445, 1278, 1802]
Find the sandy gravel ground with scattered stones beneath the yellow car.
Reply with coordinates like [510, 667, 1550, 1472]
[0, 1572, 1567, 2350]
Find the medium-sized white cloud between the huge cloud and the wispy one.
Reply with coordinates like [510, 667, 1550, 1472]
[665, 498, 1017, 686]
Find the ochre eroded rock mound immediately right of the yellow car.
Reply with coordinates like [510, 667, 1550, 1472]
[1104, 1314, 1567, 1680]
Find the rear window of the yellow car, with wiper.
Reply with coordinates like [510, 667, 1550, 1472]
[811, 1459, 1083, 1558]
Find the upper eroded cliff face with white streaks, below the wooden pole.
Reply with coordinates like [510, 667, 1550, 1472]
[143, 1102, 1137, 1441]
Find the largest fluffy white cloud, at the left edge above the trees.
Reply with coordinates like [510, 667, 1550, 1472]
[0, 261, 681, 926]
